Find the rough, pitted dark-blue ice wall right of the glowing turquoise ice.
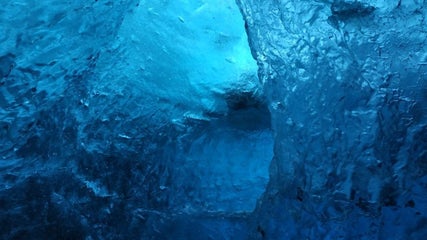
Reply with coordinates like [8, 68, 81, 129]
[237, 0, 427, 239]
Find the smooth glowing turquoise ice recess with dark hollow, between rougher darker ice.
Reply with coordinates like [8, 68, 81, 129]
[88, 0, 273, 214]
